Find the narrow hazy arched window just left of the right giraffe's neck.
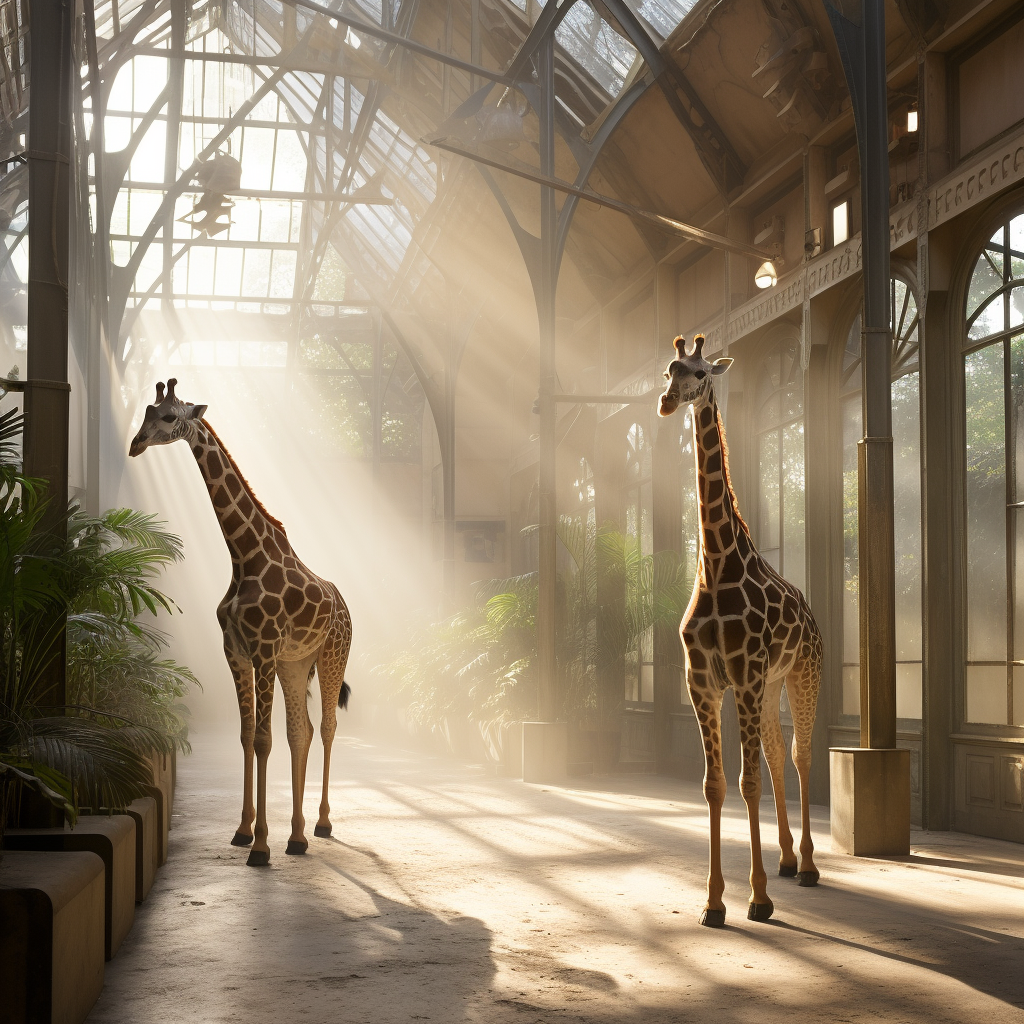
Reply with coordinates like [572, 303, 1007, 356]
[623, 423, 654, 701]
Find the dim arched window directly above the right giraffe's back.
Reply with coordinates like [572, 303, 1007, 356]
[755, 338, 805, 589]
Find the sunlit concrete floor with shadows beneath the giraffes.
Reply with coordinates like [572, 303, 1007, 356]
[89, 735, 1024, 1024]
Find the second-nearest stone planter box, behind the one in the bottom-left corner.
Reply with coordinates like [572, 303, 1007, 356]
[4, 814, 135, 959]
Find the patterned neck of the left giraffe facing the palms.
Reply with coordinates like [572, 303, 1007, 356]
[191, 421, 291, 563]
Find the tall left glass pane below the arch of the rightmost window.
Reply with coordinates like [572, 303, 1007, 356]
[964, 344, 1007, 663]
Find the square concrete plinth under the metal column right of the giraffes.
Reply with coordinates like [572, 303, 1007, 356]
[828, 746, 910, 857]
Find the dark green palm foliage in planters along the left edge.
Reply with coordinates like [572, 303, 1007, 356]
[0, 411, 196, 836]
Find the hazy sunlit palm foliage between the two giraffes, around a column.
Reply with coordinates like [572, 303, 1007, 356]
[374, 517, 690, 729]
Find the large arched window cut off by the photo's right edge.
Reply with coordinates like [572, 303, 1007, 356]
[964, 213, 1024, 726]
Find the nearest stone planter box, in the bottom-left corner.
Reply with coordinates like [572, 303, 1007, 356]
[0, 850, 104, 1024]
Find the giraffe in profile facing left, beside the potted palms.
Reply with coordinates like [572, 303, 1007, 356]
[128, 377, 352, 867]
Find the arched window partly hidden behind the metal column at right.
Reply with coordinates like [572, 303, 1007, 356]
[841, 278, 923, 719]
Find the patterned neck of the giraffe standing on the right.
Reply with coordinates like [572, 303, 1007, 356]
[693, 391, 751, 583]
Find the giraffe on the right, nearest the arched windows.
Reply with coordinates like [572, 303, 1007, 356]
[658, 334, 821, 928]
